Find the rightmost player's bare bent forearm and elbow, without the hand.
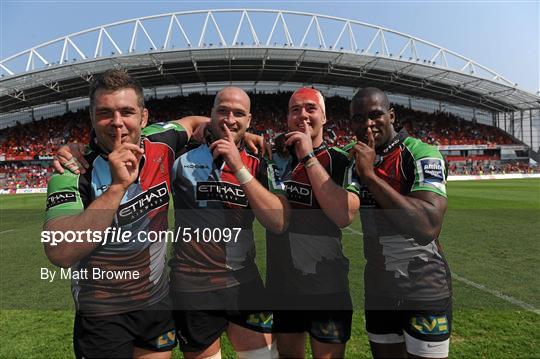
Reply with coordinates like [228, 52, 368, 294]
[362, 173, 446, 245]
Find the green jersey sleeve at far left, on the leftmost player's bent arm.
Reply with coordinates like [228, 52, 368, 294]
[45, 171, 88, 221]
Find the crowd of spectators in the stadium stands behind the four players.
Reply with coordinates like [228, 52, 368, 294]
[0, 92, 527, 188]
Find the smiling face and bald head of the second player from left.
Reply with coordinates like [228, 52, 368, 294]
[212, 88, 251, 144]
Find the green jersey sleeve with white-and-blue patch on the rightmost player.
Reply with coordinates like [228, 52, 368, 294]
[403, 137, 448, 198]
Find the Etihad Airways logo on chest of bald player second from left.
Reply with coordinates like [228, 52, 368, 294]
[196, 181, 248, 207]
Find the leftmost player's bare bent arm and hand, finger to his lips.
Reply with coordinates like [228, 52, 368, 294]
[44, 128, 143, 267]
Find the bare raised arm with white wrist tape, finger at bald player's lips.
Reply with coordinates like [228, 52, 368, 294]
[210, 125, 290, 233]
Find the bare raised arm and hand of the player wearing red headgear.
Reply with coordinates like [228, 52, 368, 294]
[285, 124, 360, 228]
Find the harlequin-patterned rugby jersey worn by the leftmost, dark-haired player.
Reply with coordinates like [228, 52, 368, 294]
[46, 123, 187, 315]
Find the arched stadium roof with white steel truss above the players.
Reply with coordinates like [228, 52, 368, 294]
[0, 9, 540, 113]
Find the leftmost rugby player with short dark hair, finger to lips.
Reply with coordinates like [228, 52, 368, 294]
[44, 70, 198, 358]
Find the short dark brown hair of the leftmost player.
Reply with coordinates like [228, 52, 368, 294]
[90, 69, 144, 113]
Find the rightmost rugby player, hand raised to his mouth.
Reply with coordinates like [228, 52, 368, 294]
[350, 88, 452, 358]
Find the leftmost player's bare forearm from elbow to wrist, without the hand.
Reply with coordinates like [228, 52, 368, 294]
[44, 185, 125, 268]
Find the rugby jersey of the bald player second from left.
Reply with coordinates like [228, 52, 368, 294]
[170, 144, 282, 292]
